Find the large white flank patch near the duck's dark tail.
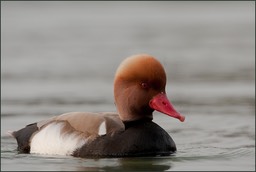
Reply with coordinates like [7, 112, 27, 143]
[30, 122, 86, 155]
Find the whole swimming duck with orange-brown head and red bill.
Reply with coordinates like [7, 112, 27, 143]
[10, 54, 185, 158]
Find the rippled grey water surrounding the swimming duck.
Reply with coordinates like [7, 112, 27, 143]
[1, 2, 255, 171]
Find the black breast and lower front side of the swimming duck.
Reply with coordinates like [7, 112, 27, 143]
[73, 121, 176, 157]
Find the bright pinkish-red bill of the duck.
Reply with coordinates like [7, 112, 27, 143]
[149, 93, 185, 122]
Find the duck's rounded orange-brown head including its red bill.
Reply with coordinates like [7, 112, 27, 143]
[114, 54, 185, 121]
